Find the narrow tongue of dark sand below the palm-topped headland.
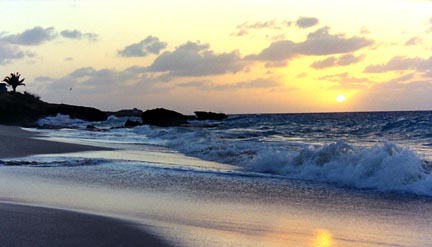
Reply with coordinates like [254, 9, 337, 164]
[0, 125, 111, 159]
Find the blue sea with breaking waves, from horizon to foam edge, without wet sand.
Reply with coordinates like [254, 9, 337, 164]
[33, 111, 432, 196]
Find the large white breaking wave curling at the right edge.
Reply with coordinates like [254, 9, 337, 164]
[248, 141, 432, 195]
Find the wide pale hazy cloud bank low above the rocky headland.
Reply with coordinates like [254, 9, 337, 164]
[32, 66, 173, 109]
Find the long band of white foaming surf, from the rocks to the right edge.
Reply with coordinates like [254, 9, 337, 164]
[34, 116, 432, 196]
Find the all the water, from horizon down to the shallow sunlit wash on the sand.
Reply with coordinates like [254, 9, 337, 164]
[0, 111, 432, 247]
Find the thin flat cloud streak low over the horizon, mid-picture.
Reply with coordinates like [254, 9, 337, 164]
[178, 78, 283, 91]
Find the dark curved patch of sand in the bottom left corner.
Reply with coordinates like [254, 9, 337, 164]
[0, 203, 168, 247]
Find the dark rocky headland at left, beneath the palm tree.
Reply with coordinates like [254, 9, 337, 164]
[0, 92, 107, 126]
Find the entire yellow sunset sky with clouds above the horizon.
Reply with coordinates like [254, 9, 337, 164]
[0, 0, 432, 114]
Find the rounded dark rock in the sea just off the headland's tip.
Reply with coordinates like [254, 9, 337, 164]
[141, 108, 188, 127]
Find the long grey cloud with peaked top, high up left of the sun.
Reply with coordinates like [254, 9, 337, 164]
[246, 27, 373, 61]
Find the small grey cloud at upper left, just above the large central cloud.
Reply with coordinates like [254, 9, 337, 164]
[118, 36, 167, 57]
